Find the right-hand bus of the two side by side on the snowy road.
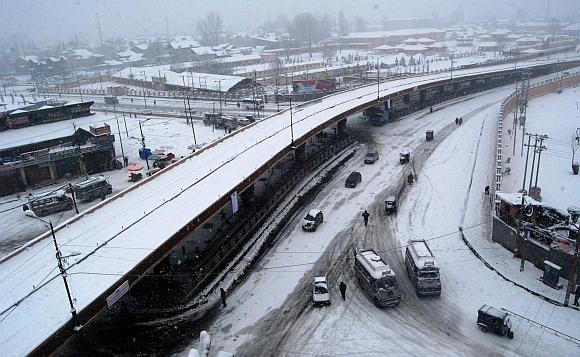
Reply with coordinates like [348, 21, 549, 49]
[405, 240, 441, 296]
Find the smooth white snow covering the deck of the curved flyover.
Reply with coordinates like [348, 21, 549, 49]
[0, 54, 578, 356]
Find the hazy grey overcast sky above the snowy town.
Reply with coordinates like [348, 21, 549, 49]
[0, 0, 580, 46]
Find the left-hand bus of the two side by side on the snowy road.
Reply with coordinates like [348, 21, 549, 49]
[354, 249, 401, 307]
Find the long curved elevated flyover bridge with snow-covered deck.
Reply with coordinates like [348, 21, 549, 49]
[0, 54, 580, 355]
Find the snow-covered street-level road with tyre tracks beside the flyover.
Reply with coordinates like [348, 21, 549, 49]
[199, 79, 580, 356]
